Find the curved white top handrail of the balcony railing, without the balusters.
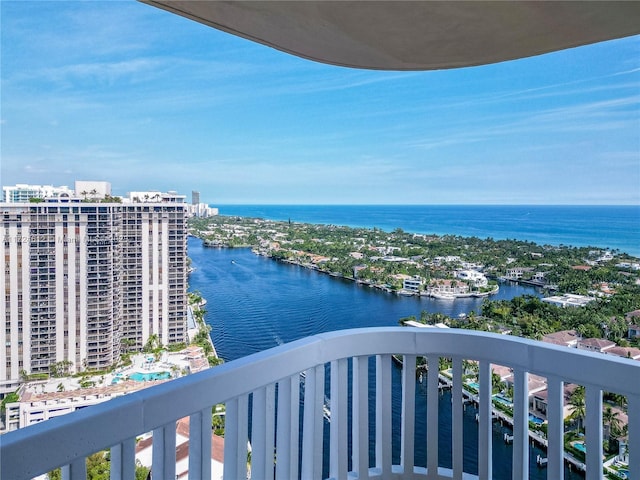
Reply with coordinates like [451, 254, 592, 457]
[0, 327, 640, 478]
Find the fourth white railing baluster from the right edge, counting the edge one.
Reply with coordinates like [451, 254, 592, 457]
[512, 368, 529, 480]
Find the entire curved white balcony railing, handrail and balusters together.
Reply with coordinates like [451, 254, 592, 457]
[0, 327, 640, 480]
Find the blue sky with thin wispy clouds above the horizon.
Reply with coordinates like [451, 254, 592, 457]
[0, 0, 640, 204]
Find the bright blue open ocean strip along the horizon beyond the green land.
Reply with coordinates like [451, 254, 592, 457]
[219, 205, 640, 257]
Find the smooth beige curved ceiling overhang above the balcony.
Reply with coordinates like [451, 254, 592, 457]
[141, 0, 640, 70]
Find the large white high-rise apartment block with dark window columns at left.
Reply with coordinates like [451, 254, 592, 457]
[0, 200, 187, 394]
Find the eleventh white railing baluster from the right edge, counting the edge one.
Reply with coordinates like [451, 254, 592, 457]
[329, 358, 349, 480]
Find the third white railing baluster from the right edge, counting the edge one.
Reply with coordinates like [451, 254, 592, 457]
[547, 376, 564, 478]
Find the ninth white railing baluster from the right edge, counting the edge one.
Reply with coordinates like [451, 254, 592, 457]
[376, 355, 391, 478]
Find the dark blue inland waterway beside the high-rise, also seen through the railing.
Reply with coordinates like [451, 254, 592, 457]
[188, 238, 580, 480]
